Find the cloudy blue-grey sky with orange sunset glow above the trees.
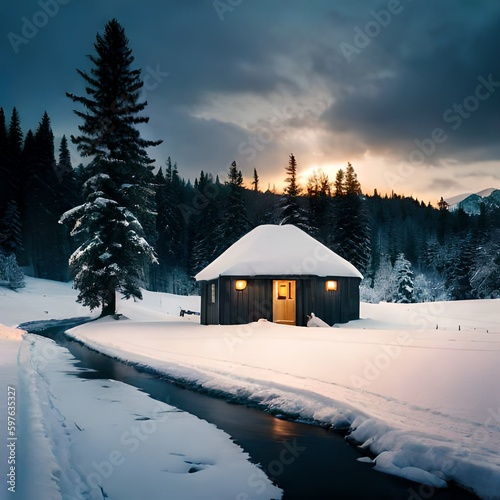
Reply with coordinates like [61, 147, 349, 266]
[0, 0, 500, 203]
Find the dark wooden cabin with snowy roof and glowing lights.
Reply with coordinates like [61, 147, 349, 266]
[196, 225, 363, 326]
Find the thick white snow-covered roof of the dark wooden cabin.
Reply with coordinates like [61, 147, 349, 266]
[195, 224, 363, 281]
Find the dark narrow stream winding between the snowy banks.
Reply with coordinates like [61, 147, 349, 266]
[20, 320, 477, 500]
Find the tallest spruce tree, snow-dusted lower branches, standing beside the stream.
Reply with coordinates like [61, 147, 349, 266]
[62, 19, 161, 315]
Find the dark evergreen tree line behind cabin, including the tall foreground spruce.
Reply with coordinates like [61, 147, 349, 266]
[0, 20, 500, 314]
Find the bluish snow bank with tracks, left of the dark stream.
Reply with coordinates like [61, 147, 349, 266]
[19, 335, 282, 500]
